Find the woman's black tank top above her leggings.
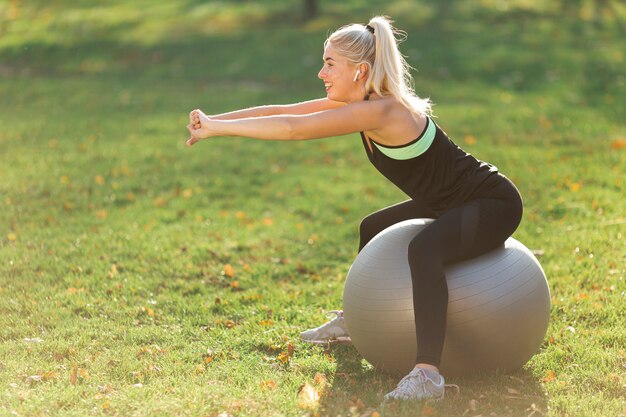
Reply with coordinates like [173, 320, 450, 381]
[361, 111, 500, 215]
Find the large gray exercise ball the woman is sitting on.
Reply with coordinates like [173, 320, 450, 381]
[343, 219, 550, 376]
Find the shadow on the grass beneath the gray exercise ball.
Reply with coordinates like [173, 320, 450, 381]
[319, 345, 547, 417]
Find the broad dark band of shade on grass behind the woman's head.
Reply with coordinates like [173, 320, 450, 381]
[0, 3, 625, 108]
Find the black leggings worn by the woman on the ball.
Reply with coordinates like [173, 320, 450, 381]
[359, 178, 522, 366]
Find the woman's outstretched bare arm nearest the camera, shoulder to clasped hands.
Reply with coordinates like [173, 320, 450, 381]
[187, 100, 389, 146]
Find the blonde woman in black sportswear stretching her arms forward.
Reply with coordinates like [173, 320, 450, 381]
[187, 17, 522, 400]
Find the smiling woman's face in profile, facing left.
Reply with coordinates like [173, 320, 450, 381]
[317, 43, 363, 103]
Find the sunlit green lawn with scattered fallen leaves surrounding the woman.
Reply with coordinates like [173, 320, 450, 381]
[0, 0, 626, 417]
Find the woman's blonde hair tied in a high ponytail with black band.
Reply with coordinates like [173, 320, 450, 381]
[324, 16, 432, 114]
